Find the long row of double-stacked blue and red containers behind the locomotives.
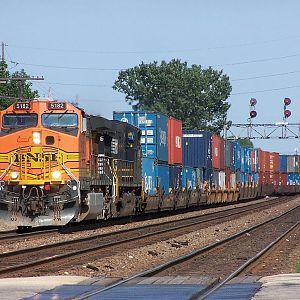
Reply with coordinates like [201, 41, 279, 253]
[114, 111, 300, 194]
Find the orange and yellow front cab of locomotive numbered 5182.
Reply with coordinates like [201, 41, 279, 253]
[0, 99, 83, 226]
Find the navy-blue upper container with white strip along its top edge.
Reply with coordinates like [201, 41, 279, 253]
[182, 130, 212, 169]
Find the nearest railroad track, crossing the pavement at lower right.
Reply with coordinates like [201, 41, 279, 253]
[73, 206, 300, 300]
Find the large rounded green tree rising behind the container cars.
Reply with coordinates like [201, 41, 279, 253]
[113, 59, 231, 133]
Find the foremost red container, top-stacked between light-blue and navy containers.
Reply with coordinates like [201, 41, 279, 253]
[168, 117, 182, 165]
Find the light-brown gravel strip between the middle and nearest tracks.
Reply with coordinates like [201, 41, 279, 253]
[34, 198, 300, 277]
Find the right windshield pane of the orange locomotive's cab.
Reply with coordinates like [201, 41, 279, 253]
[42, 113, 78, 127]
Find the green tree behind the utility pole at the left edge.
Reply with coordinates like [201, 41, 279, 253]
[0, 61, 39, 110]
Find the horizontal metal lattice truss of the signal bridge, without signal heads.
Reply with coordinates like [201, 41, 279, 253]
[223, 121, 300, 140]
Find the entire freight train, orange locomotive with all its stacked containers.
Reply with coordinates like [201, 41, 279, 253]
[0, 99, 300, 227]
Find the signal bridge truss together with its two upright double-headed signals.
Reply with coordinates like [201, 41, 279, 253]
[224, 98, 300, 140]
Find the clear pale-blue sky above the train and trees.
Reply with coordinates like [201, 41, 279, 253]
[0, 0, 300, 153]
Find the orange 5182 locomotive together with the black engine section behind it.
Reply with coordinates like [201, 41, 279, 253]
[0, 99, 141, 226]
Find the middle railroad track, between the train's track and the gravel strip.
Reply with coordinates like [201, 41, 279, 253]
[0, 195, 296, 276]
